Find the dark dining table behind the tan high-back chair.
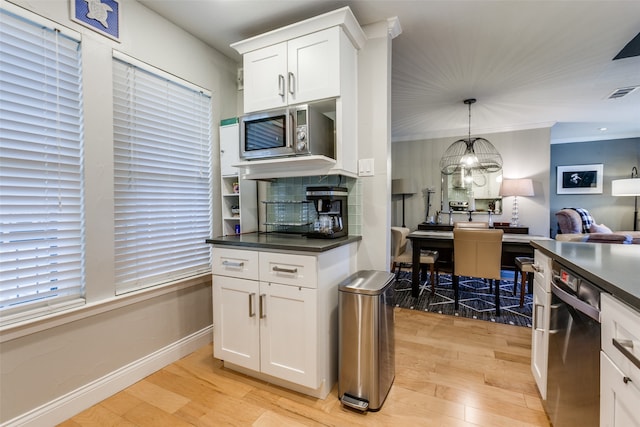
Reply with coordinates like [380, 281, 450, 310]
[407, 230, 549, 298]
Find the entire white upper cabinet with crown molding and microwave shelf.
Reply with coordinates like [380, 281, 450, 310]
[231, 7, 366, 180]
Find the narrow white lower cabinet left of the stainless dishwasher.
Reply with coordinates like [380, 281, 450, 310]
[531, 250, 551, 400]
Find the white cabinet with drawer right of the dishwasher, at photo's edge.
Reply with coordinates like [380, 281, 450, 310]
[600, 294, 640, 427]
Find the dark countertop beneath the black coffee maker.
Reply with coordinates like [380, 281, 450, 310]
[206, 233, 362, 252]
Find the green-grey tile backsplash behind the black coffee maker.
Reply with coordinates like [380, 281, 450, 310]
[261, 175, 362, 235]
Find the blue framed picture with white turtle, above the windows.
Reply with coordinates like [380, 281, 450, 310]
[69, 0, 120, 42]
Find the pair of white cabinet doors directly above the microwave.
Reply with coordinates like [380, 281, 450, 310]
[244, 27, 348, 113]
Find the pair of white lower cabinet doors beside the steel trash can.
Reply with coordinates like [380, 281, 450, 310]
[213, 276, 319, 388]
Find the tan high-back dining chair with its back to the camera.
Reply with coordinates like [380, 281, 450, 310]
[452, 228, 504, 316]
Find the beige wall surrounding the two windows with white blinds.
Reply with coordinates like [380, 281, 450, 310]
[0, 0, 237, 425]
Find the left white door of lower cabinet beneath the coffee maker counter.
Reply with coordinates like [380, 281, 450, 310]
[213, 275, 260, 371]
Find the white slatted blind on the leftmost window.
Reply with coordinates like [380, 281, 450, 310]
[0, 7, 84, 323]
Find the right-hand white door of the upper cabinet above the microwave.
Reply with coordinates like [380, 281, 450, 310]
[286, 27, 341, 104]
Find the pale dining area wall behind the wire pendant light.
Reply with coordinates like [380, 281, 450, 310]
[391, 128, 551, 236]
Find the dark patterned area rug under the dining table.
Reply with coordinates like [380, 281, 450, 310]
[395, 272, 533, 328]
